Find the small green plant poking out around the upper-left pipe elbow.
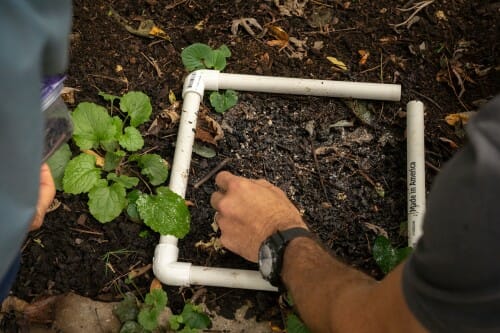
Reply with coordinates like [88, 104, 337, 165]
[181, 43, 238, 113]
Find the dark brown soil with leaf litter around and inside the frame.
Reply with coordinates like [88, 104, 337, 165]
[4, 0, 500, 322]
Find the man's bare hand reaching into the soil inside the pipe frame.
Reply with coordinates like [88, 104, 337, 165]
[210, 171, 307, 262]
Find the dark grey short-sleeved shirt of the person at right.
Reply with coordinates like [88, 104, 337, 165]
[403, 97, 500, 332]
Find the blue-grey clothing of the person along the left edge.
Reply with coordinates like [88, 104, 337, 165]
[0, 0, 72, 288]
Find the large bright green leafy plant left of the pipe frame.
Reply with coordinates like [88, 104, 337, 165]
[49, 91, 190, 238]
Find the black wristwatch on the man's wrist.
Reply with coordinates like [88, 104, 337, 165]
[259, 227, 312, 287]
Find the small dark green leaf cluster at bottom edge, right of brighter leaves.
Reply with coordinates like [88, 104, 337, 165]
[168, 303, 212, 333]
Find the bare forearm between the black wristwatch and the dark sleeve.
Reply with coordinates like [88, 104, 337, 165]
[282, 238, 423, 332]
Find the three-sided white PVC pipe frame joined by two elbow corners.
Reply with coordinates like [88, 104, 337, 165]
[153, 70, 401, 291]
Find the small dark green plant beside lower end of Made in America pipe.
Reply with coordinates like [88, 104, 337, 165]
[373, 236, 412, 274]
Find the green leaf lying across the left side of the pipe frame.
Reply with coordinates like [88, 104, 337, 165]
[136, 187, 191, 238]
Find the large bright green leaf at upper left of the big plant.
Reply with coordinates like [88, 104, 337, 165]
[71, 102, 118, 149]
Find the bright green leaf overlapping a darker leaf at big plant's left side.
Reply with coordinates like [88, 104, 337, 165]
[63, 154, 101, 194]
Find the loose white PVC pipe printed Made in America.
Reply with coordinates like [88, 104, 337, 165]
[406, 101, 425, 248]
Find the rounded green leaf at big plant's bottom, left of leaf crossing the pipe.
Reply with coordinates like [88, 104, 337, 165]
[89, 183, 127, 223]
